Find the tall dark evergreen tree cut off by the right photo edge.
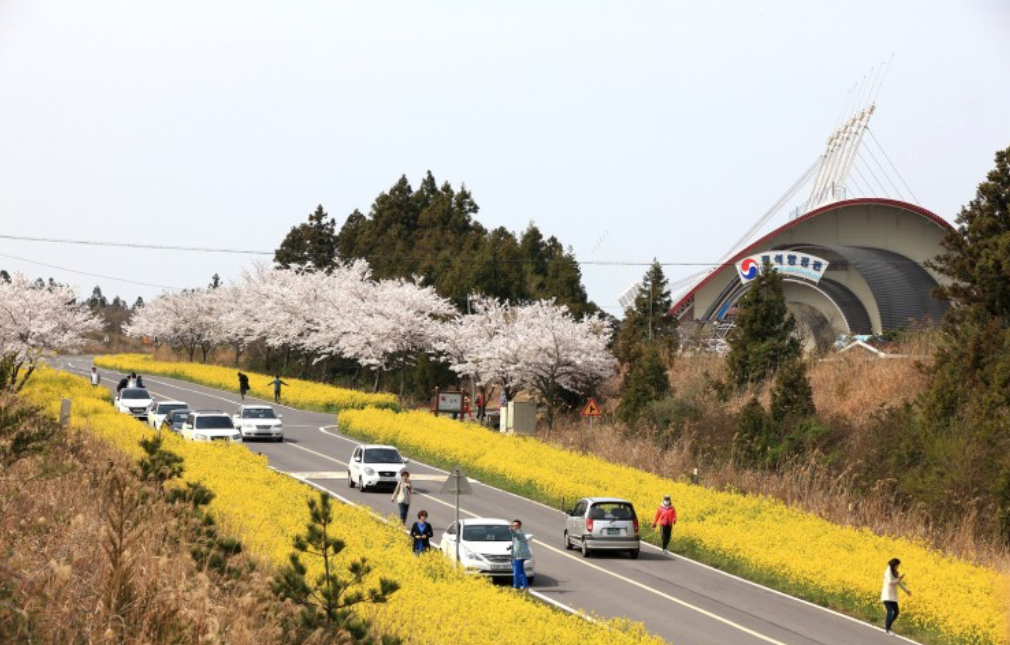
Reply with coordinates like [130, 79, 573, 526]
[921, 143, 1010, 543]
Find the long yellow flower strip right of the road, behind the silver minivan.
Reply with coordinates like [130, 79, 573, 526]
[338, 409, 1010, 645]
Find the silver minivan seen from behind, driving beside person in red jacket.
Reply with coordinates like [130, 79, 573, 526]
[565, 498, 641, 558]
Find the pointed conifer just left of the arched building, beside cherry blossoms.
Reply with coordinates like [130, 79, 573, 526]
[615, 261, 680, 366]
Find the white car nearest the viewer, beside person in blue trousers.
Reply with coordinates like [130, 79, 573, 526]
[439, 518, 536, 584]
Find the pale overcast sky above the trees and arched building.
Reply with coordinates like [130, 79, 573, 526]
[0, 0, 1010, 314]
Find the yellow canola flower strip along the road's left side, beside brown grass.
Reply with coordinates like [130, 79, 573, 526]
[22, 369, 665, 645]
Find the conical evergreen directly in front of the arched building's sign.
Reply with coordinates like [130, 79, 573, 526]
[726, 262, 800, 388]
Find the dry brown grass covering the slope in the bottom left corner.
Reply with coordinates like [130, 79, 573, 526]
[0, 413, 349, 645]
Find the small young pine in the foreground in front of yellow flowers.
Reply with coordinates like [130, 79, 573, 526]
[273, 493, 399, 642]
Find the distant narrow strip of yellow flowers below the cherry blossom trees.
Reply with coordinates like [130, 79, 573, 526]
[95, 354, 400, 412]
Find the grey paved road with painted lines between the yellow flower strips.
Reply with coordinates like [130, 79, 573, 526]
[61, 357, 917, 645]
